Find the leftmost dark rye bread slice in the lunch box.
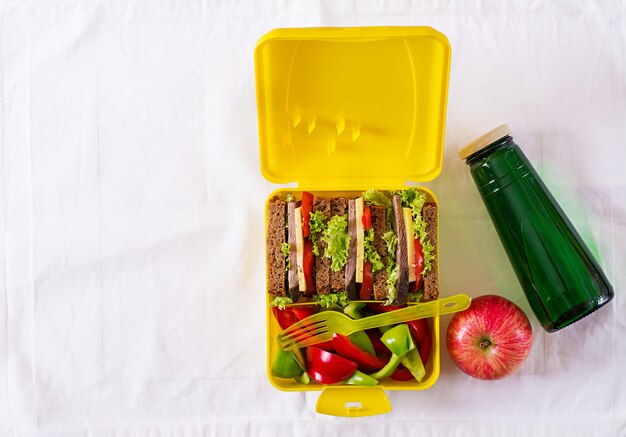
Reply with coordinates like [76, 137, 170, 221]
[265, 197, 287, 296]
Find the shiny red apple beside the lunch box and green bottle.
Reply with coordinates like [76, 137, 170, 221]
[446, 295, 533, 379]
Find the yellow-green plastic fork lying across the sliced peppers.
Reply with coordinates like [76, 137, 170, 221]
[278, 294, 472, 351]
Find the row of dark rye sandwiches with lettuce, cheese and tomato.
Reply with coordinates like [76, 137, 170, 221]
[266, 187, 439, 306]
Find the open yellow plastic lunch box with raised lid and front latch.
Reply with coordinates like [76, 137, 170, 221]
[255, 27, 450, 417]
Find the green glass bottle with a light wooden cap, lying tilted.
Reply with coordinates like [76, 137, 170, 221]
[459, 125, 614, 332]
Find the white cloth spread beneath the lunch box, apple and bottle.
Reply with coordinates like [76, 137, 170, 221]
[0, 0, 626, 436]
